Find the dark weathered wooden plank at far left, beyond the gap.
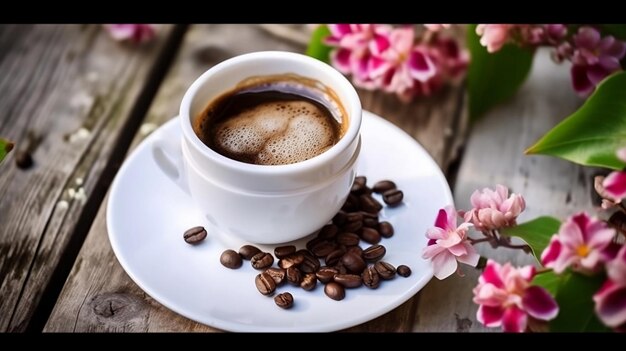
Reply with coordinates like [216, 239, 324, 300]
[0, 25, 176, 331]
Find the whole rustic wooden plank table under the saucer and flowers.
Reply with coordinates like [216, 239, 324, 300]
[0, 25, 593, 332]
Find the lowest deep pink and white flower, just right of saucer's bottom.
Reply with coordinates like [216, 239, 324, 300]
[473, 260, 559, 333]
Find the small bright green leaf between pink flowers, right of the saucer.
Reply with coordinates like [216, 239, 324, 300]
[500, 216, 561, 262]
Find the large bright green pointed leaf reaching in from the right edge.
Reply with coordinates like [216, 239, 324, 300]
[525, 72, 626, 169]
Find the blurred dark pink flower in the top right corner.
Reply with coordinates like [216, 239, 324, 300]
[571, 26, 626, 97]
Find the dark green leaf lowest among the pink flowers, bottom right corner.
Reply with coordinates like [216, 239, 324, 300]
[550, 271, 609, 332]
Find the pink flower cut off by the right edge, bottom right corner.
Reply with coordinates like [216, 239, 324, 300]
[593, 245, 626, 331]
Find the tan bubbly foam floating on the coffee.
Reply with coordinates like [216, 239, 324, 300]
[215, 101, 338, 165]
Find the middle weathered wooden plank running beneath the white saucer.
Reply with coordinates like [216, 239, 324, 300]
[44, 25, 464, 331]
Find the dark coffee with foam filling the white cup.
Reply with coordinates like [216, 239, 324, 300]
[193, 74, 348, 165]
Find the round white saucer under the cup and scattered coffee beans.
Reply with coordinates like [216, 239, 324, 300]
[107, 111, 452, 332]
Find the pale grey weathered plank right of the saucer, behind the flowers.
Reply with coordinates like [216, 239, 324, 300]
[414, 51, 593, 331]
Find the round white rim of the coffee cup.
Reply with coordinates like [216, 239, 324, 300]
[179, 51, 362, 174]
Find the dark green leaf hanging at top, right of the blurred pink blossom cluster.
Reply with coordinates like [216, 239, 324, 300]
[467, 25, 534, 121]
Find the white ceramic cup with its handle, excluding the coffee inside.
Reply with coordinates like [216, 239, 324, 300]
[152, 51, 362, 244]
